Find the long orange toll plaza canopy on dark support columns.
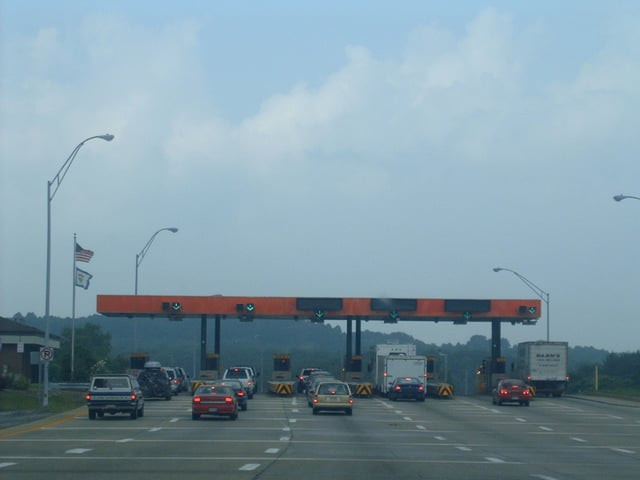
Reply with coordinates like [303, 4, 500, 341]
[96, 295, 541, 382]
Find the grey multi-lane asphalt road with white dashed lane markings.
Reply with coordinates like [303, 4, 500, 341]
[0, 394, 640, 480]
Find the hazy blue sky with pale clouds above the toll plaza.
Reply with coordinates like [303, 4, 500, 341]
[0, 0, 640, 352]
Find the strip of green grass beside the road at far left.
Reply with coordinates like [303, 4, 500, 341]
[0, 386, 85, 412]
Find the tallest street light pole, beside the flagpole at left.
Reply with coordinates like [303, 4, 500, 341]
[42, 133, 114, 408]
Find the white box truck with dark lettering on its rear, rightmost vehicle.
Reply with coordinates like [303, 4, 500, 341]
[516, 341, 569, 397]
